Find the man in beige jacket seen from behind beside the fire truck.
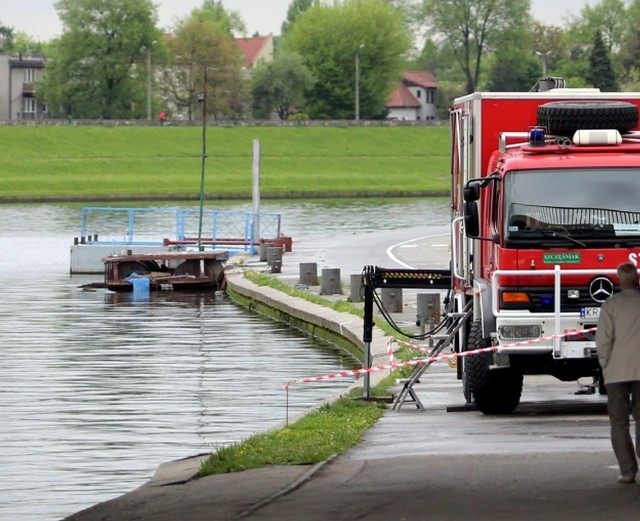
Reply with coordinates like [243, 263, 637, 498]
[596, 262, 640, 483]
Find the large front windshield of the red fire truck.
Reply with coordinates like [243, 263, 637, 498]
[503, 168, 640, 248]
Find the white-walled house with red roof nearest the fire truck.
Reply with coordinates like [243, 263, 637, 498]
[386, 71, 439, 121]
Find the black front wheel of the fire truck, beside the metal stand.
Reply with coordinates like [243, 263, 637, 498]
[462, 320, 522, 414]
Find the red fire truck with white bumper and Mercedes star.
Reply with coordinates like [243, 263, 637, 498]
[451, 78, 640, 414]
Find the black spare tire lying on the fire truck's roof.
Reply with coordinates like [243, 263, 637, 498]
[538, 101, 638, 136]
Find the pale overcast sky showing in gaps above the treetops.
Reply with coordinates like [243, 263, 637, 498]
[0, 0, 599, 41]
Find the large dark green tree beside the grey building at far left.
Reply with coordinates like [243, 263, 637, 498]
[42, 0, 159, 118]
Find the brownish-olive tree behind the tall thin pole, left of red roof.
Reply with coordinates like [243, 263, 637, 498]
[160, 10, 245, 120]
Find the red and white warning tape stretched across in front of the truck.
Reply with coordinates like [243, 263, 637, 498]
[284, 327, 597, 389]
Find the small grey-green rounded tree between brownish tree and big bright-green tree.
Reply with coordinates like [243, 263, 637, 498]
[251, 52, 313, 120]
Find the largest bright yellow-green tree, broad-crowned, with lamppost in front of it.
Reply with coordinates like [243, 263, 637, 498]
[282, 0, 411, 119]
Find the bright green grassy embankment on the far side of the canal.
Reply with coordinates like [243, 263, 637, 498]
[0, 126, 449, 202]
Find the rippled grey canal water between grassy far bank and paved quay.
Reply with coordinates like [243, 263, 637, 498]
[0, 199, 448, 521]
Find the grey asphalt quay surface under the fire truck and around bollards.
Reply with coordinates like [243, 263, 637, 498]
[61, 232, 640, 521]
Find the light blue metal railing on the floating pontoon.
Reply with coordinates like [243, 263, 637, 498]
[80, 206, 281, 254]
